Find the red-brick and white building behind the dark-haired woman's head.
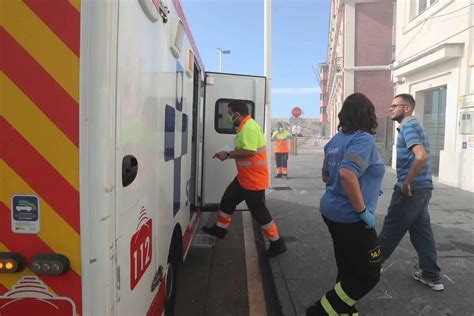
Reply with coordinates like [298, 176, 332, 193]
[320, 0, 394, 163]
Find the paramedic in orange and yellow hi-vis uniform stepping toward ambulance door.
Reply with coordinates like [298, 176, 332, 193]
[202, 100, 286, 257]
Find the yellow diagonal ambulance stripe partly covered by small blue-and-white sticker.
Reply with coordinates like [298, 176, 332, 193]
[0, 160, 81, 275]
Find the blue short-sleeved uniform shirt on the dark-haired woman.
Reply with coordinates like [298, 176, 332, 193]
[319, 131, 385, 223]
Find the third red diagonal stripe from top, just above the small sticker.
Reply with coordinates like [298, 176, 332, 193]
[0, 117, 80, 234]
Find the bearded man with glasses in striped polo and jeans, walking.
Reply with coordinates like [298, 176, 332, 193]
[379, 94, 444, 291]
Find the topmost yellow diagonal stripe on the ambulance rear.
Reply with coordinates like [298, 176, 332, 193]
[0, 0, 79, 102]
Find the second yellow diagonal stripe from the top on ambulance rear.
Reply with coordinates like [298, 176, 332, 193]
[0, 72, 79, 191]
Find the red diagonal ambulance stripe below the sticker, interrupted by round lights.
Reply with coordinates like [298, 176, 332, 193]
[0, 202, 82, 312]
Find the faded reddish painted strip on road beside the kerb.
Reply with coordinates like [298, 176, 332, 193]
[242, 212, 267, 316]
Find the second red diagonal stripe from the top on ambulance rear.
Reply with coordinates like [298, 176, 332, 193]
[0, 27, 79, 146]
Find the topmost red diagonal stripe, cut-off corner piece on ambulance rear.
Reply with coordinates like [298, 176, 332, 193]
[24, 0, 81, 57]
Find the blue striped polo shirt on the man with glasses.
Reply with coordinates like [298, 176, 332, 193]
[397, 116, 433, 190]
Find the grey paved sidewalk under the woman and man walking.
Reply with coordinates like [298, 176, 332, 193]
[267, 150, 474, 316]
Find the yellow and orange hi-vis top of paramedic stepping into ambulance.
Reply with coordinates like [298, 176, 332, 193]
[235, 115, 270, 191]
